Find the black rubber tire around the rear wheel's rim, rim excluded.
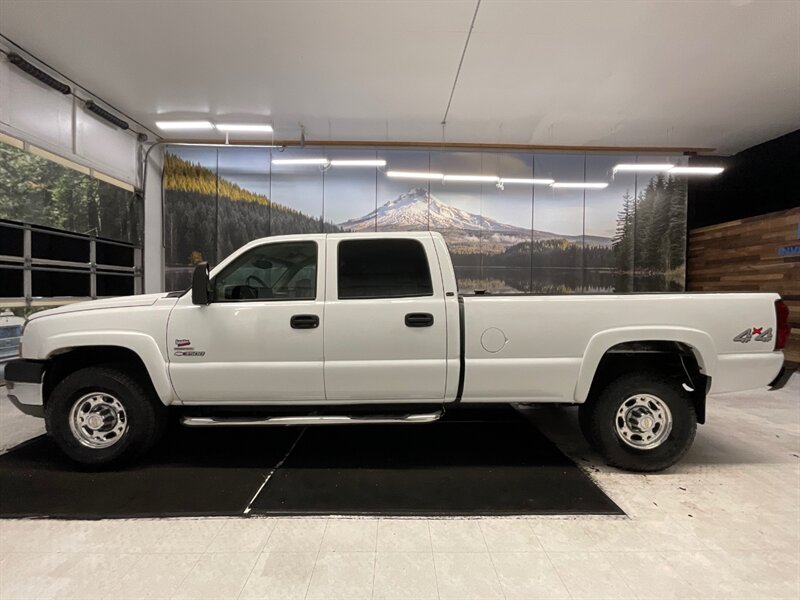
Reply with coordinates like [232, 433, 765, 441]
[581, 373, 697, 472]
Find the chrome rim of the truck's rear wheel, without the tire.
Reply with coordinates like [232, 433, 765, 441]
[614, 394, 672, 450]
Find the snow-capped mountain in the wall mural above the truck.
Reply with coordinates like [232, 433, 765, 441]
[339, 188, 611, 245]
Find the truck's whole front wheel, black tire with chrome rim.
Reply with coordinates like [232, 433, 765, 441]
[45, 367, 166, 466]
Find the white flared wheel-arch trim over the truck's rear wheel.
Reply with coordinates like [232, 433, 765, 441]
[575, 327, 717, 403]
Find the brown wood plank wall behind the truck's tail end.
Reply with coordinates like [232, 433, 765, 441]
[686, 208, 800, 363]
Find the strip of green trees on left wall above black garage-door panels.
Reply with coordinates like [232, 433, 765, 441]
[0, 142, 143, 244]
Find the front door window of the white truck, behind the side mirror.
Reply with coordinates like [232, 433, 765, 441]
[214, 242, 317, 302]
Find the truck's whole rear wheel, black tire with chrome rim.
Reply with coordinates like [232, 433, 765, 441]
[580, 373, 697, 471]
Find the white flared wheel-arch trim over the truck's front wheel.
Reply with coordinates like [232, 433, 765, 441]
[40, 331, 175, 405]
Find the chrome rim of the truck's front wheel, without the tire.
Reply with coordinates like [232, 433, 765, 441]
[69, 392, 128, 450]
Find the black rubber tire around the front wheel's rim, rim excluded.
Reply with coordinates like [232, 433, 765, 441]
[44, 367, 167, 468]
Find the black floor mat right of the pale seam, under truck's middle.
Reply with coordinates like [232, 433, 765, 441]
[247, 409, 624, 516]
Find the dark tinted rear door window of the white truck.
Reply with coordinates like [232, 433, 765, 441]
[338, 239, 433, 299]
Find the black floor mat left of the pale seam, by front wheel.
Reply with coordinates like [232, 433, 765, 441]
[0, 426, 300, 519]
